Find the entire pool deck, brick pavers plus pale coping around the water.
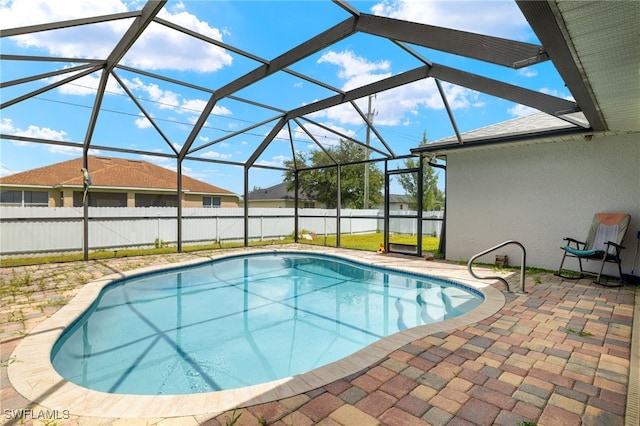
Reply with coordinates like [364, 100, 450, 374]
[0, 245, 640, 426]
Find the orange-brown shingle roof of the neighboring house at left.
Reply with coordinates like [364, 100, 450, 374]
[0, 156, 233, 195]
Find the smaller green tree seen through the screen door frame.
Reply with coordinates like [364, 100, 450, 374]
[398, 132, 444, 210]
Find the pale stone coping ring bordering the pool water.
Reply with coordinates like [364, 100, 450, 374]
[8, 246, 506, 418]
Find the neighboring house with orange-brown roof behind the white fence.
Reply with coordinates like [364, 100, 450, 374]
[0, 156, 239, 208]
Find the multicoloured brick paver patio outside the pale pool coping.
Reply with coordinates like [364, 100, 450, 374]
[0, 248, 638, 426]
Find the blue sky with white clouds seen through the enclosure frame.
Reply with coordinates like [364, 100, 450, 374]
[0, 0, 571, 195]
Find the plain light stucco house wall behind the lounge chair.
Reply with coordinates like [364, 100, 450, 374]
[446, 133, 640, 275]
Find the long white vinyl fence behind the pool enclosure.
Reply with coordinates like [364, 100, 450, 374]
[0, 206, 443, 255]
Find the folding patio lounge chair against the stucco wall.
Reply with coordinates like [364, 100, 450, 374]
[556, 213, 631, 285]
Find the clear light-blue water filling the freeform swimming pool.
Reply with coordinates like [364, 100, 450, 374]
[52, 253, 483, 395]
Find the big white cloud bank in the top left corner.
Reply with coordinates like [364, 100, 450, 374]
[0, 0, 233, 72]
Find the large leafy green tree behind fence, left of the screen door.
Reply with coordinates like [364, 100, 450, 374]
[284, 140, 384, 209]
